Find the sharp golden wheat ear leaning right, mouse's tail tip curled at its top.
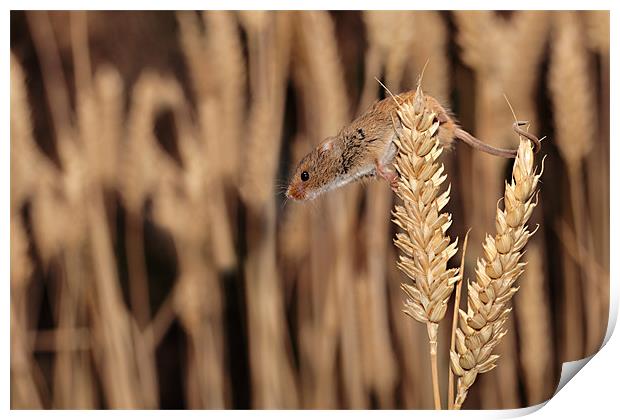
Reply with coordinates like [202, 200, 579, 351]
[450, 139, 542, 409]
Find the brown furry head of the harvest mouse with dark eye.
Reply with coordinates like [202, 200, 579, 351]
[286, 137, 339, 201]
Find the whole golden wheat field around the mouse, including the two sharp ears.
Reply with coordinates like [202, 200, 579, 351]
[10, 11, 610, 409]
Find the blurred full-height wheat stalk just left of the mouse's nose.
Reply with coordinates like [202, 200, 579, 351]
[240, 11, 298, 408]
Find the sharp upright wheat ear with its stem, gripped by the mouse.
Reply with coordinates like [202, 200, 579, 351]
[393, 86, 459, 409]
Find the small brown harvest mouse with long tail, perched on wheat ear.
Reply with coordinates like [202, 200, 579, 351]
[286, 90, 531, 201]
